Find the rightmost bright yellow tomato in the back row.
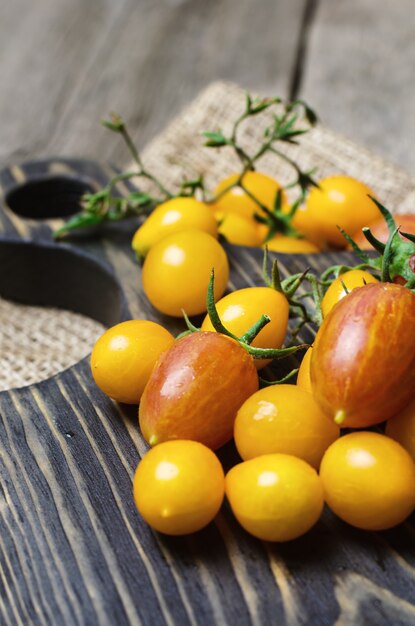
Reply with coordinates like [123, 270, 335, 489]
[306, 175, 379, 248]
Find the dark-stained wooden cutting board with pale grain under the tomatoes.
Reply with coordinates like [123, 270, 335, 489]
[0, 159, 415, 626]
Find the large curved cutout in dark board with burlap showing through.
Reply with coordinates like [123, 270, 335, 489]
[0, 240, 126, 391]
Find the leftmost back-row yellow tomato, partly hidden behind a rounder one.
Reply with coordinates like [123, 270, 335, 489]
[132, 198, 218, 257]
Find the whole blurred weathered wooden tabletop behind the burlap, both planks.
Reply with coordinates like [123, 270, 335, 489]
[0, 0, 415, 170]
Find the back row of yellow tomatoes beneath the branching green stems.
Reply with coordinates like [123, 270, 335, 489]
[133, 171, 394, 256]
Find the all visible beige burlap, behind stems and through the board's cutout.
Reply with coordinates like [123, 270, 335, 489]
[0, 82, 415, 389]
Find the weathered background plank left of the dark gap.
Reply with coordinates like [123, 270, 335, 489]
[0, 0, 305, 164]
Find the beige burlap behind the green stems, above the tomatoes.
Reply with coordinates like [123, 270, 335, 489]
[138, 82, 415, 207]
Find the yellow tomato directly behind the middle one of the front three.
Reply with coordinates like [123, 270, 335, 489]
[234, 385, 340, 469]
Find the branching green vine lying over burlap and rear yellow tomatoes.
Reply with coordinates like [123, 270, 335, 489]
[54, 94, 317, 239]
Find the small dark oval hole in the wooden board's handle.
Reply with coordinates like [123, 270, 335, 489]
[6, 175, 94, 220]
